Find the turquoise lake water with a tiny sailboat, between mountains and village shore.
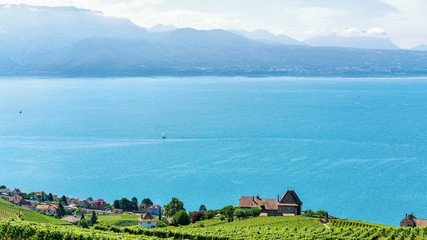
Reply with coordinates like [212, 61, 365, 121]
[0, 77, 427, 225]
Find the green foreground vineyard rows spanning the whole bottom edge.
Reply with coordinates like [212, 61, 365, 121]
[0, 209, 427, 240]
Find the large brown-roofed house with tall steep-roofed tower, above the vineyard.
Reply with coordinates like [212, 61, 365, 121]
[239, 190, 302, 216]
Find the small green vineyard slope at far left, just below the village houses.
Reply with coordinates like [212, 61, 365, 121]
[0, 199, 69, 225]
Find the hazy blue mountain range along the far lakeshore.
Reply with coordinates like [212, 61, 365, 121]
[0, 4, 427, 76]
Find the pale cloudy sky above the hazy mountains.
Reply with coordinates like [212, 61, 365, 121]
[1, 0, 427, 48]
